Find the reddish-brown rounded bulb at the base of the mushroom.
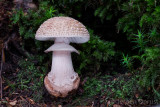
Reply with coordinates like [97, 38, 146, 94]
[44, 76, 80, 97]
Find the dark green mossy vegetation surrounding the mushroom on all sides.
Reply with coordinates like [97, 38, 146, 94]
[0, 0, 160, 107]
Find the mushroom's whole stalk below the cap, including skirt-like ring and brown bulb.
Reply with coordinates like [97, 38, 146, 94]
[44, 42, 80, 97]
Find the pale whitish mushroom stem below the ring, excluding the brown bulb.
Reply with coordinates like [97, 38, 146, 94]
[48, 51, 78, 87]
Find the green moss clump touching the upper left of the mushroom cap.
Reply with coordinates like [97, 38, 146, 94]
[11, 2, 56, 39]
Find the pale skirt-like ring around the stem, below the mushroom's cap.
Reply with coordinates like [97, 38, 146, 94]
[45, 43, 79, 54]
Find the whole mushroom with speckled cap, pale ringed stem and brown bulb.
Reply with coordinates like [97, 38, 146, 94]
[35, 17, 90, 97]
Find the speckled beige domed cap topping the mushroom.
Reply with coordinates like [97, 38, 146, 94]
[35, 16, 90, 43]
